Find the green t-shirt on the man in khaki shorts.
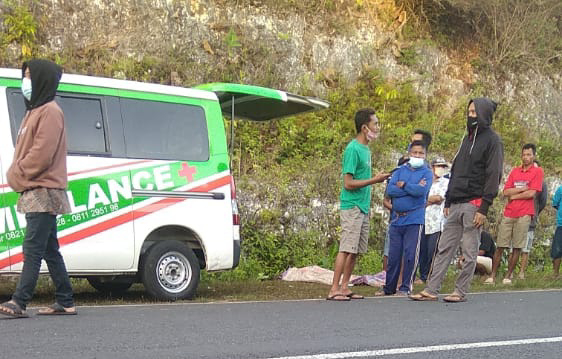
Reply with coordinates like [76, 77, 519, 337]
[340, 139, 371, 213]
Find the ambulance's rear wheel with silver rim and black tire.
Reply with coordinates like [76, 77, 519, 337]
[141, 240, 200, 301]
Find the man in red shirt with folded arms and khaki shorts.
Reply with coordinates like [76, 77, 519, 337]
[484, 143, 544, 284]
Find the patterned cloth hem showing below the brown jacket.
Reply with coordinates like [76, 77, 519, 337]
[18, 187, 71, 215]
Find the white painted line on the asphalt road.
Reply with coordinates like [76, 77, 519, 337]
[269, 337, 562, 359]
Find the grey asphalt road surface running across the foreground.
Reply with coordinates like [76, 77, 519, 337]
[0, 290, 562, 359]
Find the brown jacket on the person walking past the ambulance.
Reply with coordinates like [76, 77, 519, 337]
[7, 101, 67, 192]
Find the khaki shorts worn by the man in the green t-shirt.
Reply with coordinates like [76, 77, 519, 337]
[340, 207, 369, 254]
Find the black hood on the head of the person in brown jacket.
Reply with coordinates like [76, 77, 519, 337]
[21, 59, 62, 110]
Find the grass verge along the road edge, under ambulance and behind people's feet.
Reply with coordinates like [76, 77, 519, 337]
[0, 270, 562, 306]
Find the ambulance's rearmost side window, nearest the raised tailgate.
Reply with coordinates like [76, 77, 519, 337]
[121, 98, 209, 161]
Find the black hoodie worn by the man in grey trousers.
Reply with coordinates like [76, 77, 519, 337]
[445, 98, 503, 215]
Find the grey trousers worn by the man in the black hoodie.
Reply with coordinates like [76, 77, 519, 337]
[425, 203, 481, 297]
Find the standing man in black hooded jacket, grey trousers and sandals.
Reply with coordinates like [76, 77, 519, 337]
[410, 98, 503, 302]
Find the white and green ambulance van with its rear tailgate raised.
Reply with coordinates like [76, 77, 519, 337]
[0, 68, 328, 300]
